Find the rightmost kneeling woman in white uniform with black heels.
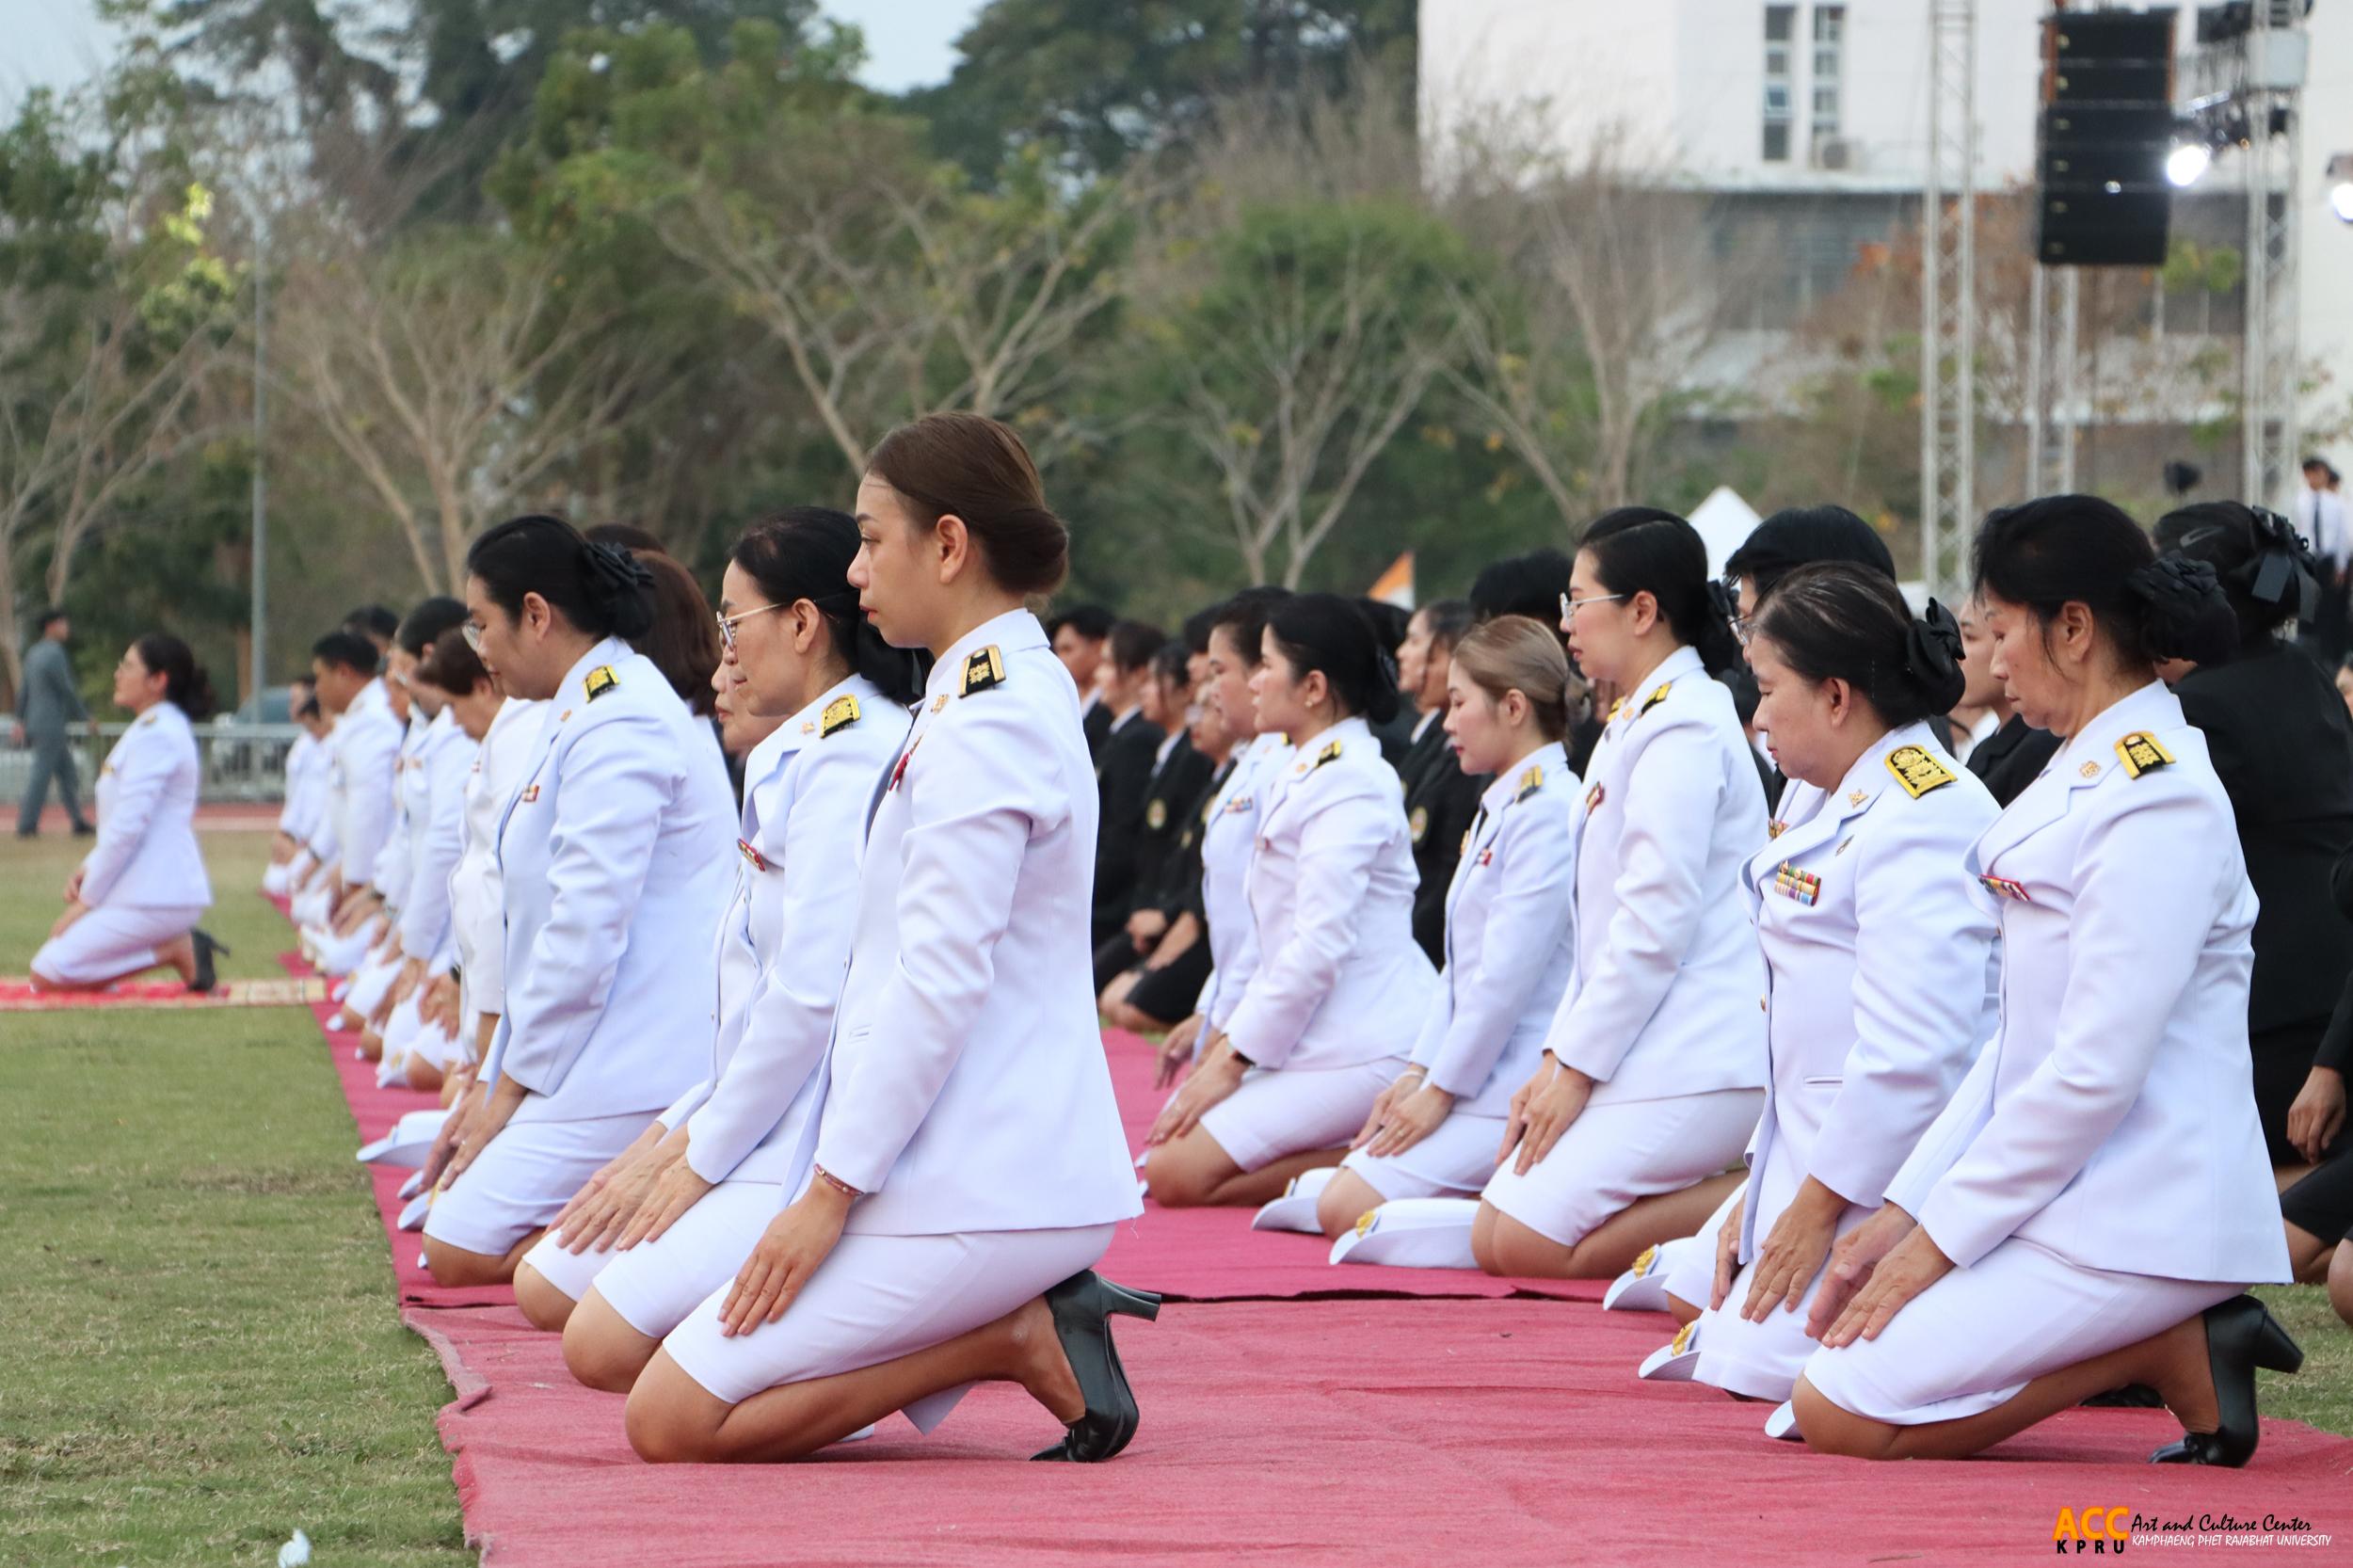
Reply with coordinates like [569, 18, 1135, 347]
[1793, 497, 2301, 1464]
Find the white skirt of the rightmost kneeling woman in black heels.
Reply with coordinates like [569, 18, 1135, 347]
[1805, 1236, 2245, 1427]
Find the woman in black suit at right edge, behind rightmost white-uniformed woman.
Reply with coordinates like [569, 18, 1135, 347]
[2158, 502, 2353, 1168]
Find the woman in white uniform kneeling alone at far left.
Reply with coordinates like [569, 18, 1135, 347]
[33, 631, 226, 991]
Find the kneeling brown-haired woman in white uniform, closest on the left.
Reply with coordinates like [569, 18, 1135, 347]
[629, 414, 1160, 1460]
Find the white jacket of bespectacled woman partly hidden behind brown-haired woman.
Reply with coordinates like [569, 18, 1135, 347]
[671, 676, 908, 1182]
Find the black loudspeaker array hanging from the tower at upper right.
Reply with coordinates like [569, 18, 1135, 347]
[2036, 8, 2174, 266]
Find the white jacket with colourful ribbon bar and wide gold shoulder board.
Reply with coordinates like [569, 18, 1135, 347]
[1741, 723, 2000, 1262]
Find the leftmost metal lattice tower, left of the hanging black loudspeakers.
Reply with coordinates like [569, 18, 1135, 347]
[1920, 0, 1977, 602]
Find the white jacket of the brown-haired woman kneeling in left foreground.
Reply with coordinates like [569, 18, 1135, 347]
[786, 610, 1144, 1236]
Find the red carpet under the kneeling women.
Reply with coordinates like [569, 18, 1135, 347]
[289, 960, 2353, 1568]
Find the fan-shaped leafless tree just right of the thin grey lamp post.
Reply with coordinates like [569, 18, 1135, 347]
[273, 224, 662, 591]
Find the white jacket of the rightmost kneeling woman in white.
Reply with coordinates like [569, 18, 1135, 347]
[1887, 680, 2287, 1283]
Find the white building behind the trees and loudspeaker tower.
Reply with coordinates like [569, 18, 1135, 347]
[1421, 0, 2353, 499]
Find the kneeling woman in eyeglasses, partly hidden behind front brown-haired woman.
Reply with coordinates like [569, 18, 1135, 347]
[516, 506, 922, 1365]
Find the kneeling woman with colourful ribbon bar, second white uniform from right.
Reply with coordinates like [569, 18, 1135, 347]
[1678, 565, 2000, 1403]
